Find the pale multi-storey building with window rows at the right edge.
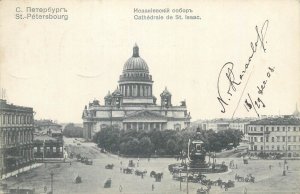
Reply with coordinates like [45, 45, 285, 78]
[247, 116, 300, 157]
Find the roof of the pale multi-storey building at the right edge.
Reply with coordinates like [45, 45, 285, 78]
[250, 117, 300, 125]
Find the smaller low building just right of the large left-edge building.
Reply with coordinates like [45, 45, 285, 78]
[34, 120, 63, 159]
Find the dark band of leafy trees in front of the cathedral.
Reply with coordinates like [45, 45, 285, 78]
[94, 127, 243, 156]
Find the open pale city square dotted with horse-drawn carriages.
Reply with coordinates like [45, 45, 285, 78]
[2, 138, 300, 194]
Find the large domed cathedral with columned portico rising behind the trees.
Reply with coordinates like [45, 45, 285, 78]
[82, 45, 191, 139]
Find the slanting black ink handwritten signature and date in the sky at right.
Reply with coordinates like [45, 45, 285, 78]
[217, 20, 274, 114]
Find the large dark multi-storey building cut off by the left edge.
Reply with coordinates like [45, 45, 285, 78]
[0, 99, 34, 176]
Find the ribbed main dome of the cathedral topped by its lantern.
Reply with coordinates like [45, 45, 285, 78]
[123, 44, 149, 72]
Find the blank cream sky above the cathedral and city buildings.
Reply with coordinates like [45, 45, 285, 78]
[0, 0, 300, 123]
